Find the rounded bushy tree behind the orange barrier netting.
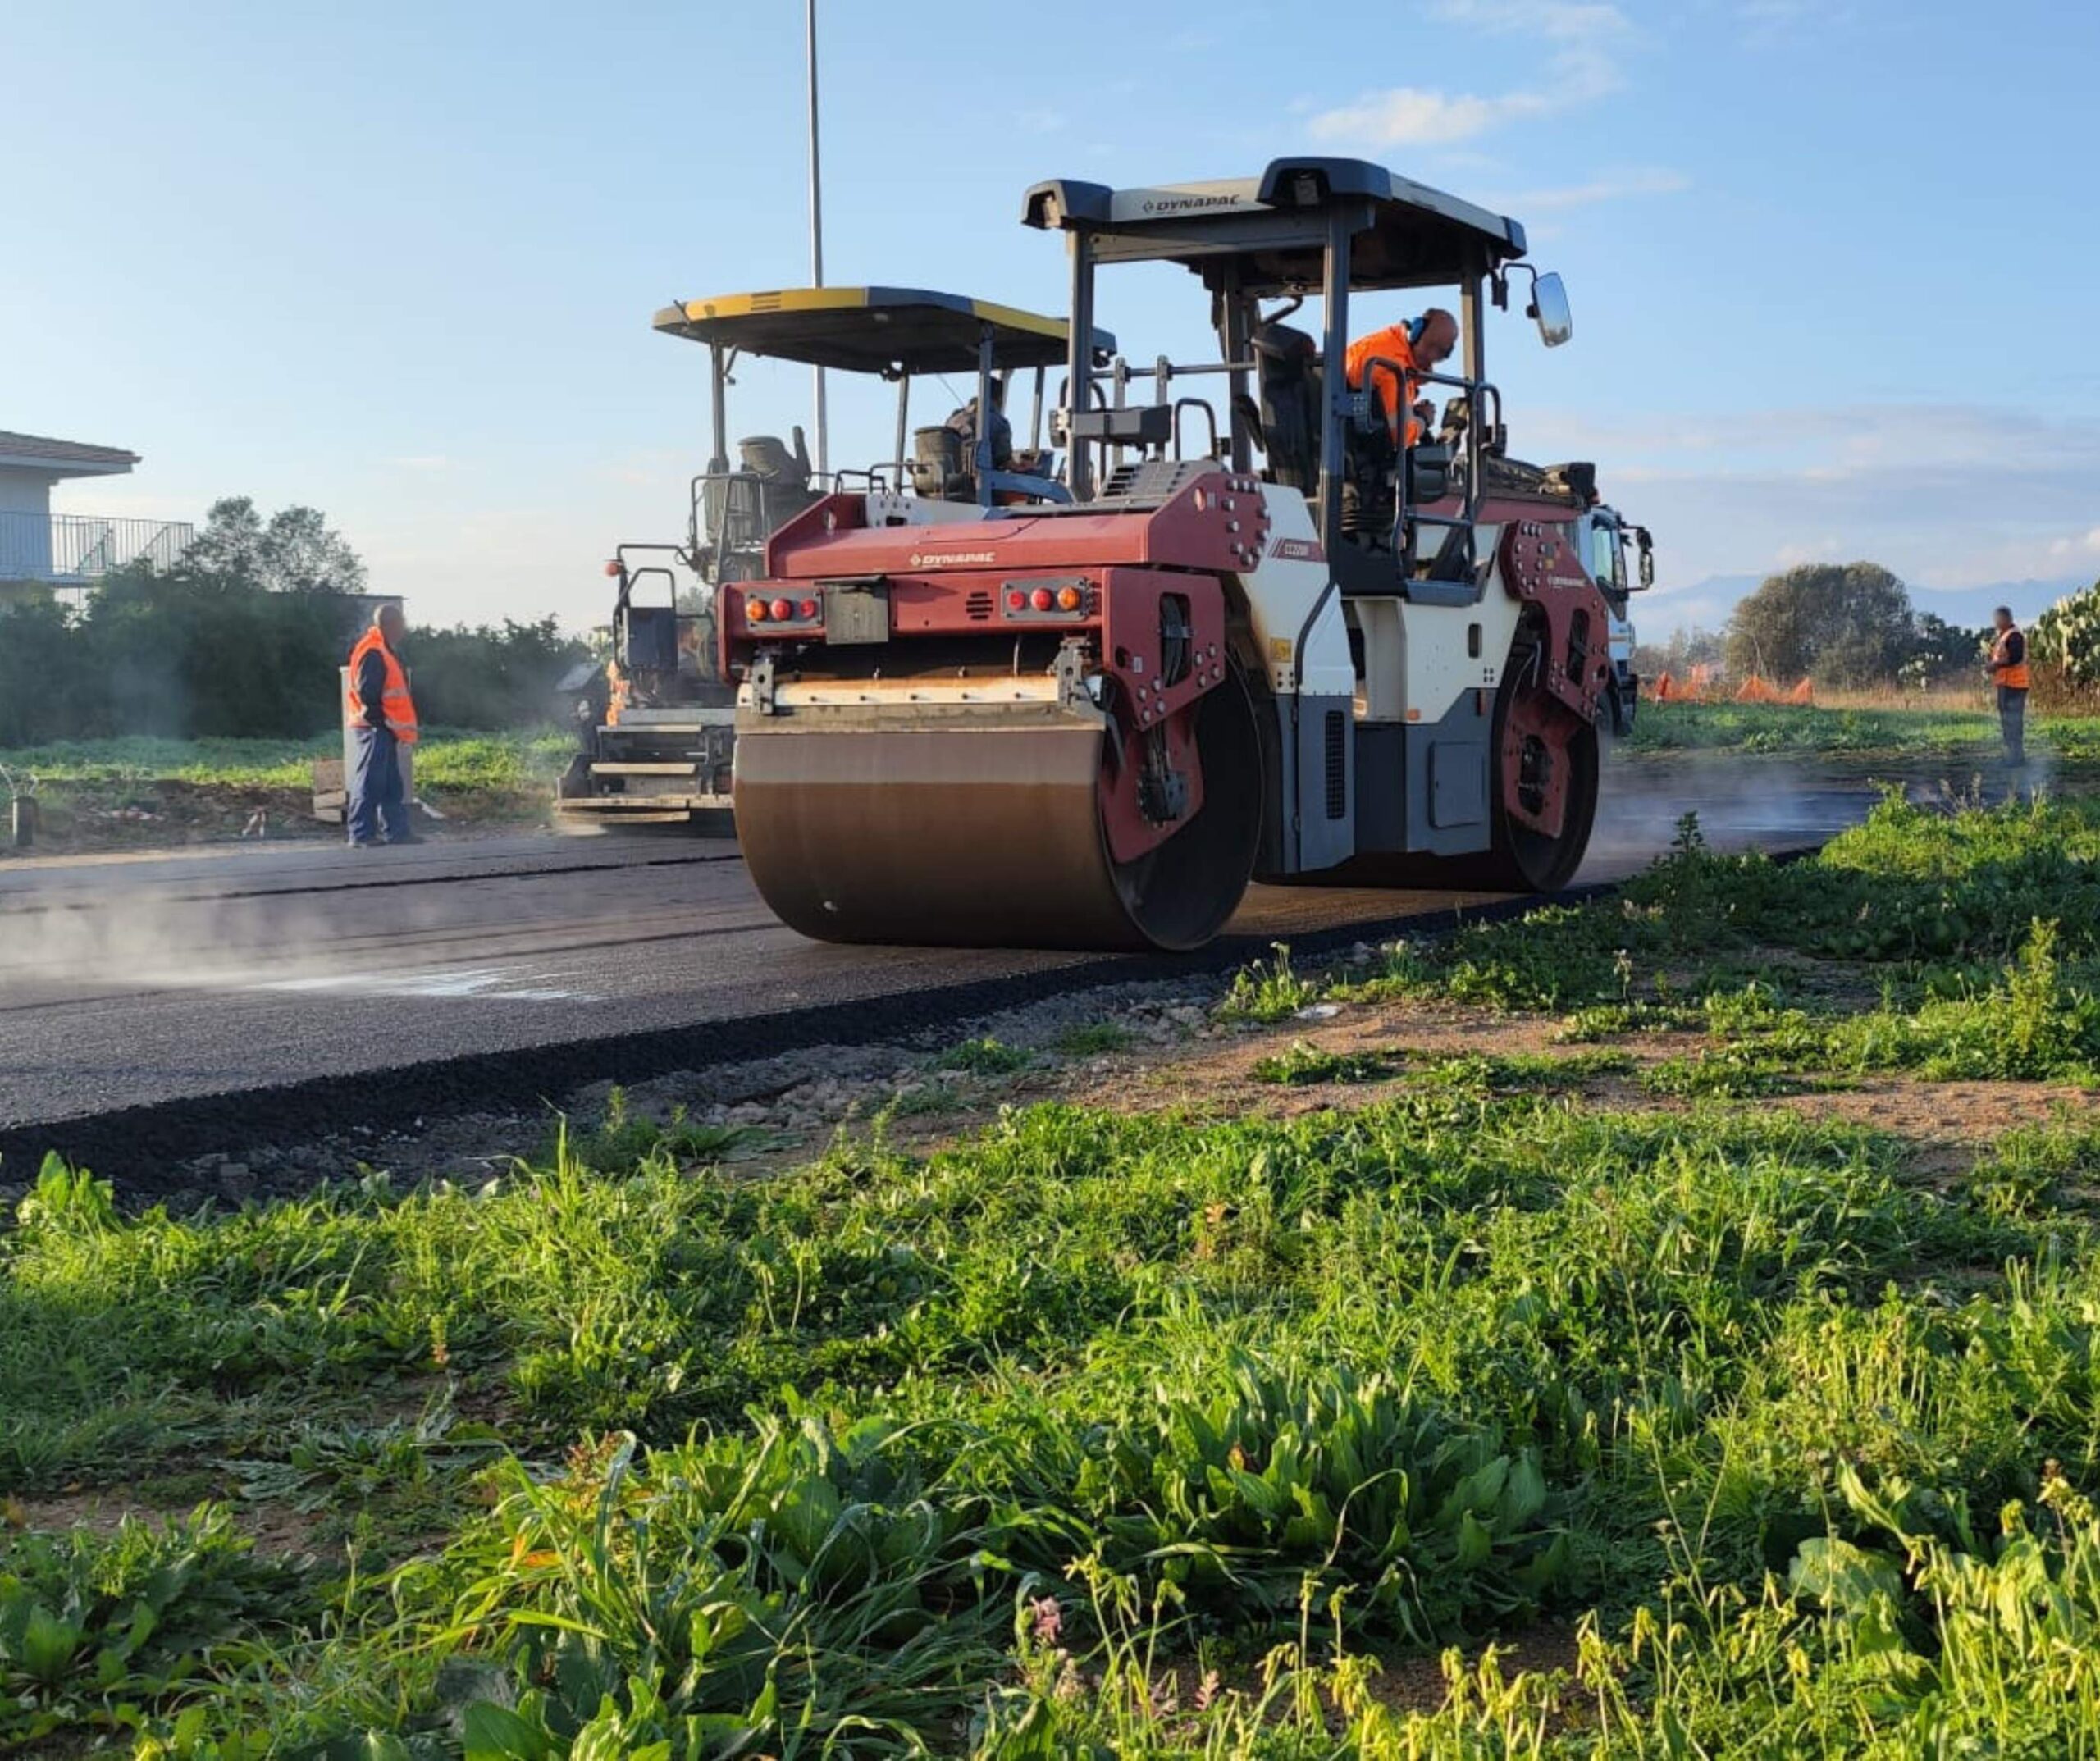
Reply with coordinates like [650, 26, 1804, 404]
[1726, 563, 1917, 687]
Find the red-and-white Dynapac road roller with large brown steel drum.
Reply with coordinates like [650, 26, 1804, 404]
[719, 157, 1613, 951]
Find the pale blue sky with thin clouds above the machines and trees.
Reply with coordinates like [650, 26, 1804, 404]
[0, 0, 2100, 627]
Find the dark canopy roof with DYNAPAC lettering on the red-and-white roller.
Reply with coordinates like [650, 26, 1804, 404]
[1023, 159, 1525, 296]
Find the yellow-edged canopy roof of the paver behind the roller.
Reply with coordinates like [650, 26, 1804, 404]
[655, 288, 1115, 376]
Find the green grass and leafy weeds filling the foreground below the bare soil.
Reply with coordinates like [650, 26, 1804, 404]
[0, 1083, 2100, 1754]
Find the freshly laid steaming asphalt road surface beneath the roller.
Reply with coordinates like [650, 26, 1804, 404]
[0, 762, 1874, 1161]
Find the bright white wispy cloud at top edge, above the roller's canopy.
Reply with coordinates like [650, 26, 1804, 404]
[1308, 0, 1632, 147]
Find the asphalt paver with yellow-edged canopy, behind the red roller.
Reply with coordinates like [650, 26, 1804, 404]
[555, 288, 1115, 833]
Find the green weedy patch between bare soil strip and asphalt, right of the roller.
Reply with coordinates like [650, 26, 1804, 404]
[1233, 793, 2100, 1096]
